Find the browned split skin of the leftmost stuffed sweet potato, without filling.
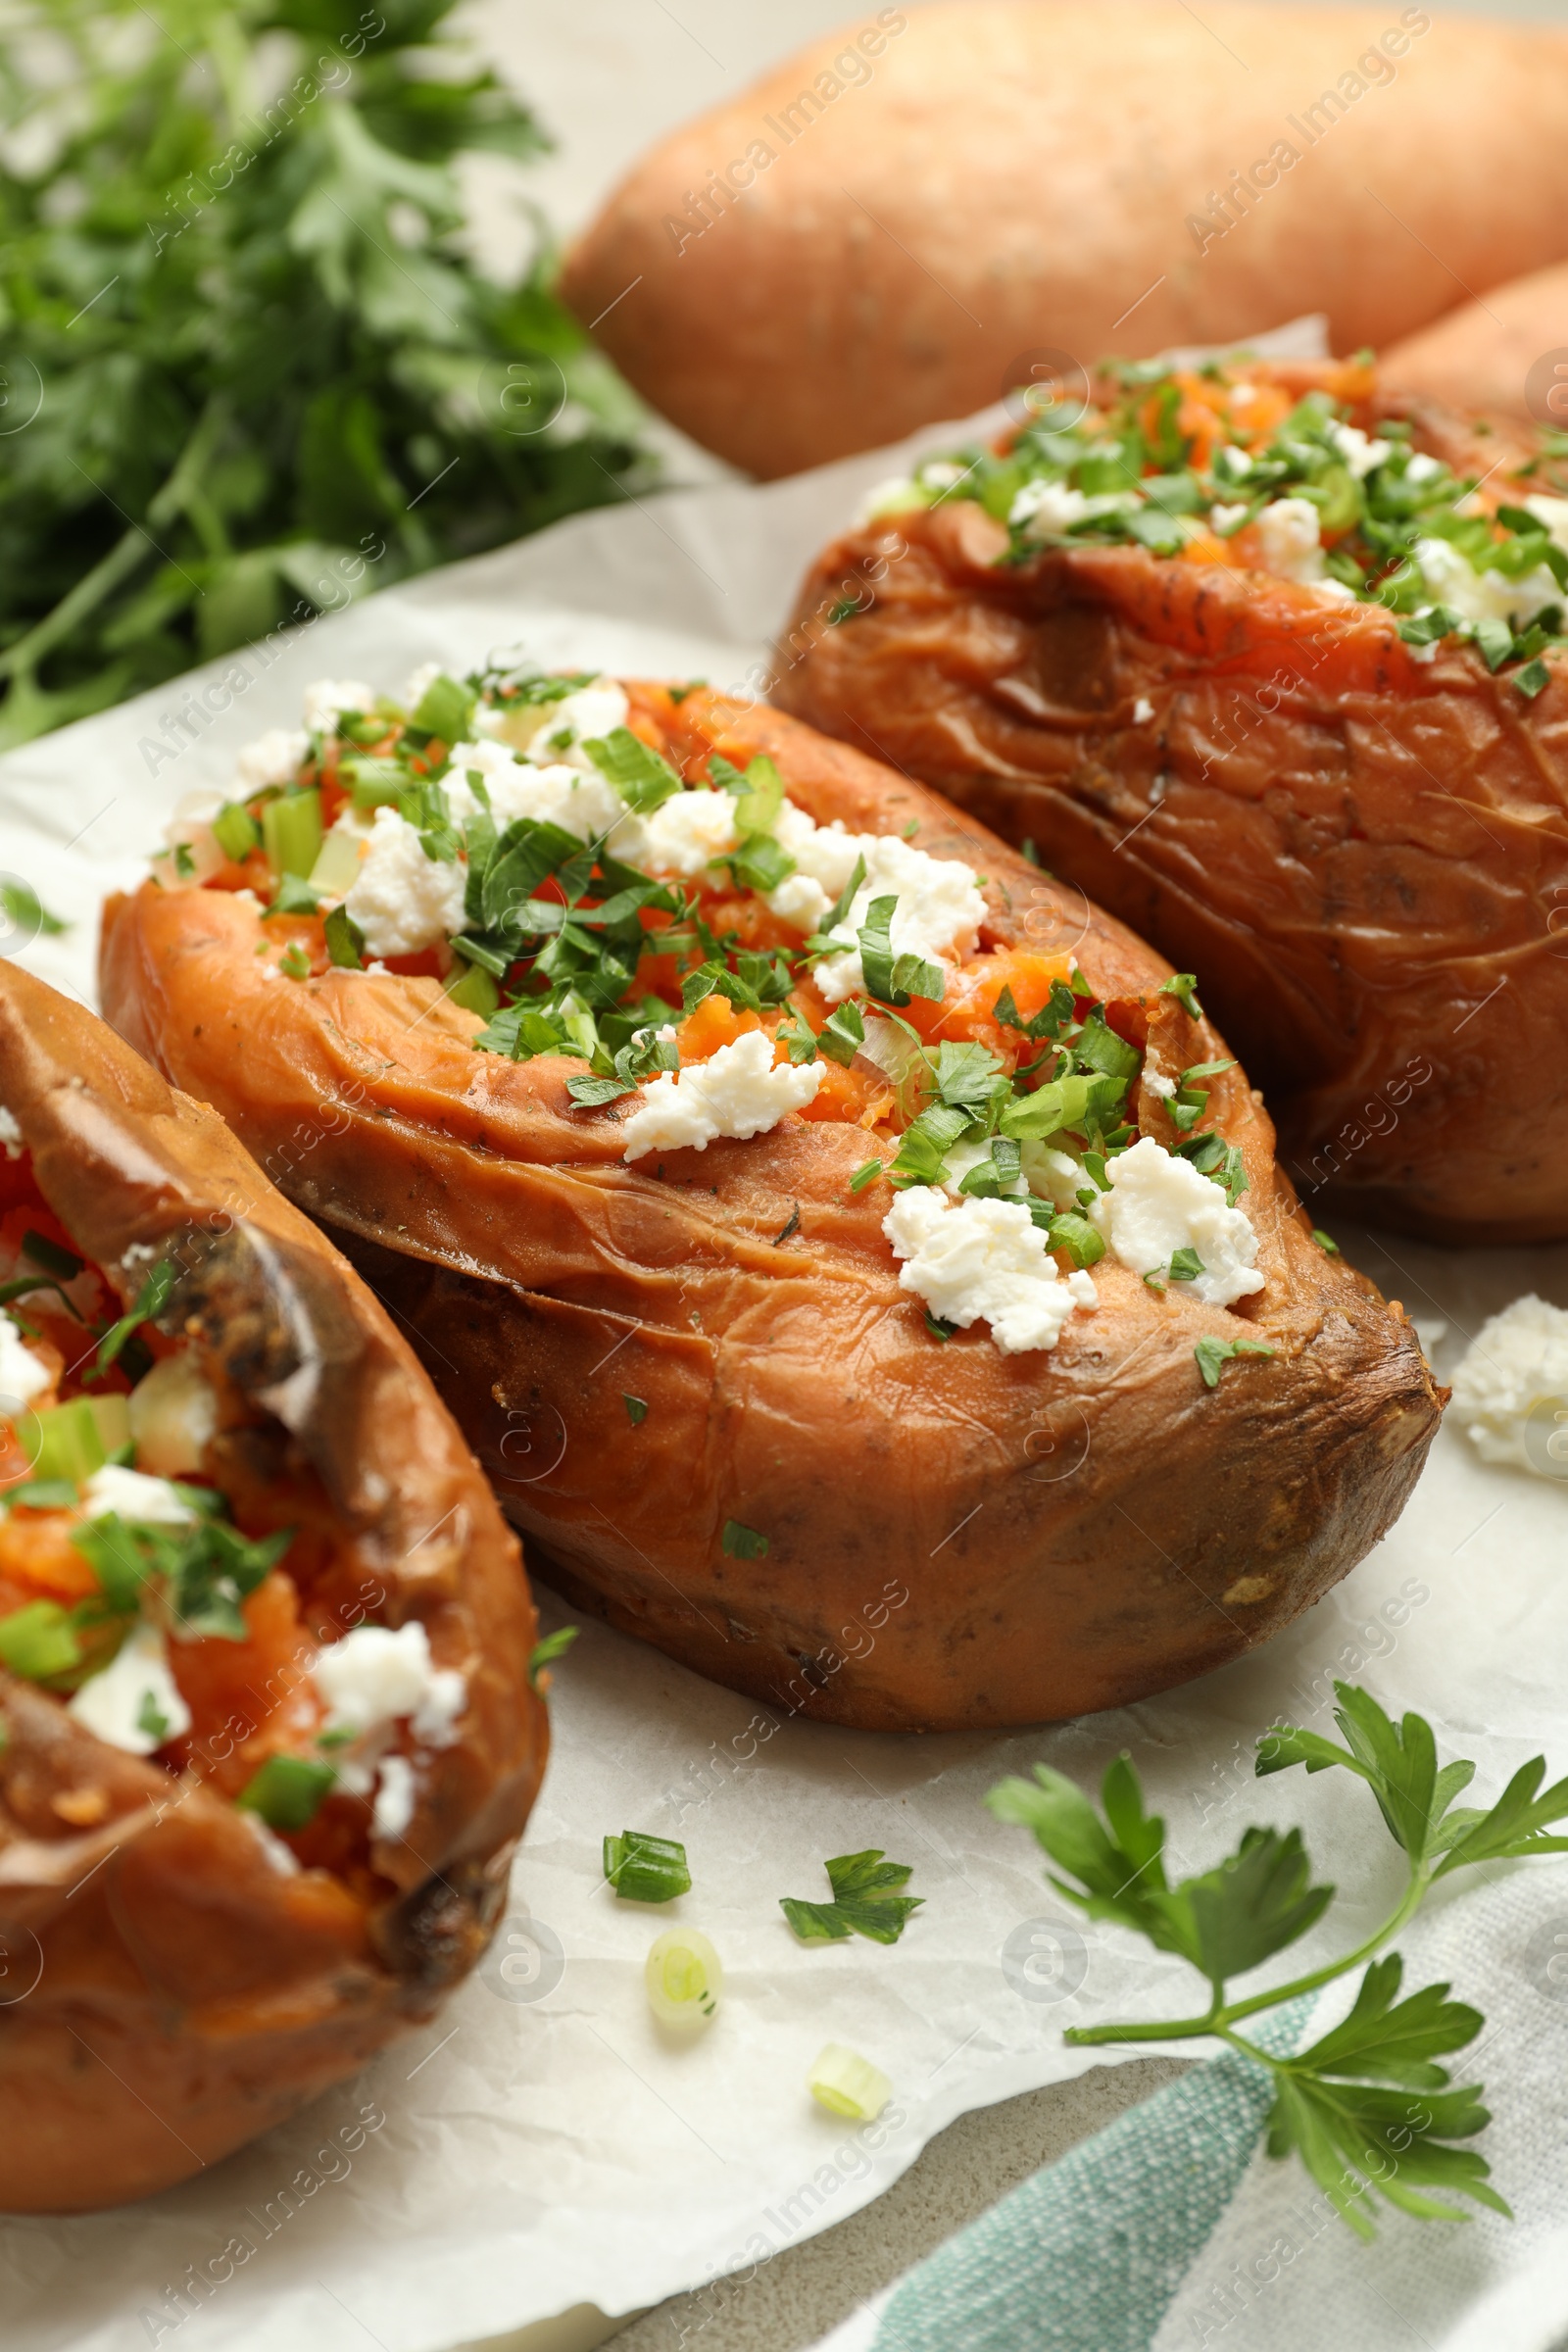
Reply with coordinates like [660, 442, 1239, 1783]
[0, 962, 548, 2211]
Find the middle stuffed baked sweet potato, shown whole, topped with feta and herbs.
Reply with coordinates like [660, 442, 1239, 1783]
[101, 675, 1439, 1729]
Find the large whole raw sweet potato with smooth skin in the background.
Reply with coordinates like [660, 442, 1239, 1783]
[562, 0, 1568, 480]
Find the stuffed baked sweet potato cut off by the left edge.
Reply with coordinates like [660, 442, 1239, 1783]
[0, 962, 546, 2213]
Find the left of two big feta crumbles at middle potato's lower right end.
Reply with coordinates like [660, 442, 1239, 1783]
[882, 1183, 1098, 1354]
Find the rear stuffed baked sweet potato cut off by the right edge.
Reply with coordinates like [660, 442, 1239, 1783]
[776, 365, 1568, 1242]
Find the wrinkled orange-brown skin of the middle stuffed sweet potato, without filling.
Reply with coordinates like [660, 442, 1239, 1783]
[104, 689, 1441, 1729]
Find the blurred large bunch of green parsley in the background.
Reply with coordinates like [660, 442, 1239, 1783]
[0, 0, 637, 746]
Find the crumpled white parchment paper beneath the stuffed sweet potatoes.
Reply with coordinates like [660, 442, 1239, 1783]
[0, 331, 1568, 2352]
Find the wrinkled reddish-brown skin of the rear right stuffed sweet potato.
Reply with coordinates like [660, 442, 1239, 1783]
[773, 402, 1568, 1242]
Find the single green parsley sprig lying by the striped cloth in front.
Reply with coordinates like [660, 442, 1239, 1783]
[987, 1682, 1568, 2236]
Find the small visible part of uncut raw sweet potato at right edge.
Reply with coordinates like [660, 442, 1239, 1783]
[1378, 261, 1568, 433]
